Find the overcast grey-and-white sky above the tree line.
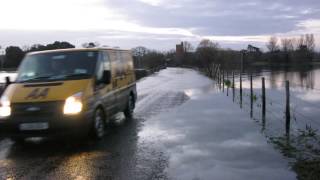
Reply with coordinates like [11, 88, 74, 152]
[0, 0, 320, 50]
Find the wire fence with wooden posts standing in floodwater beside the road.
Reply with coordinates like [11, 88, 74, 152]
[202, 65, 320, 138]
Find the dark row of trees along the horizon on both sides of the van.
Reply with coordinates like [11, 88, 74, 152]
[2, 34, 320, 72]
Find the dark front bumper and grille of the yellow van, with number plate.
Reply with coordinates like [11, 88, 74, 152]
[0, 102, 92, 137]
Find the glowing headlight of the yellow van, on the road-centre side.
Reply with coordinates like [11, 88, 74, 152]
[63, 92, 82, 115]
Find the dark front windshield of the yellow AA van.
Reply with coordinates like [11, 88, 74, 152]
[16, 51, 98, 82]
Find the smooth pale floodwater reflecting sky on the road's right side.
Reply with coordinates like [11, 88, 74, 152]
[139, 92, 295, 179]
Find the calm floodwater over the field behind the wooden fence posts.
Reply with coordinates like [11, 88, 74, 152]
[229, 64, 320, 138]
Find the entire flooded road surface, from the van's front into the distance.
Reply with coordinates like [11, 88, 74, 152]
[0, 68, 296, 180]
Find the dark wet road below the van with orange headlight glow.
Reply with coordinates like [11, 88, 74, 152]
[0, 114, 146, 179]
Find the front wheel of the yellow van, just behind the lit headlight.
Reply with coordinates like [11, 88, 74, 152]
[91, 108, 106, 140]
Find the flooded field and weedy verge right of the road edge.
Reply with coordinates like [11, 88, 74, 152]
[225, 66, 320, 177]
